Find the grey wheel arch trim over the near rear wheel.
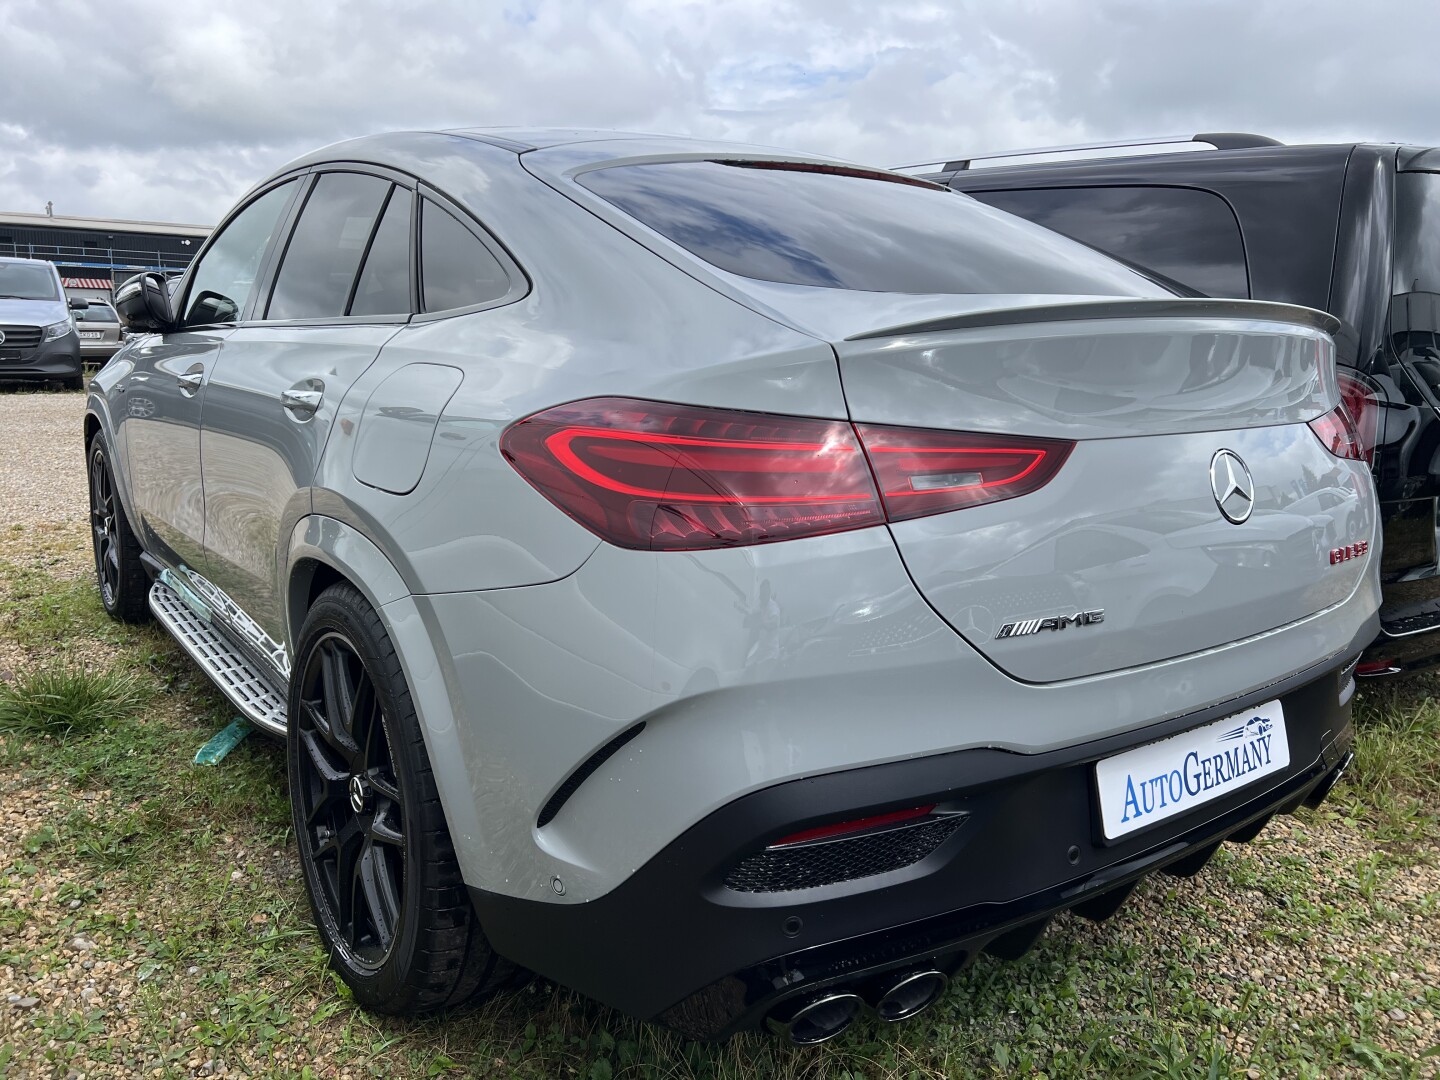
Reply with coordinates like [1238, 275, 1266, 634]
[285, 514, 482, 883]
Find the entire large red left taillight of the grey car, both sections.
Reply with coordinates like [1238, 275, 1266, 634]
[500, 397, 1073, 550]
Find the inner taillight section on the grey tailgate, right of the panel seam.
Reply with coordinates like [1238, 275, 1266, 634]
[857, 423, 1074, 521]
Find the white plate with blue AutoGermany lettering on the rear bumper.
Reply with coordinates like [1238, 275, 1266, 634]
[1094, 701, 1290, 840]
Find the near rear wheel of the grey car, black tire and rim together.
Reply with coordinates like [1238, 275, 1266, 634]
[288, 583, 517, 1015]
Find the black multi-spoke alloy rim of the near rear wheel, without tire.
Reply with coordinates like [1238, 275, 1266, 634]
[294, 632, 406, 971]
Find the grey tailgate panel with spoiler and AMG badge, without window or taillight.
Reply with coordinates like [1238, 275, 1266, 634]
[837, 300, 1375, 683]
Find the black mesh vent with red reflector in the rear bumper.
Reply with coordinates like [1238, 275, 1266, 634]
[724, 814, 965, 893]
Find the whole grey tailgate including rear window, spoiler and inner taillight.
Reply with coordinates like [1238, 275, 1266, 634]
[550, 156, 1375, 683]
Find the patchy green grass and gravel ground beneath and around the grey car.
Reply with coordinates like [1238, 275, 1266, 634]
[0, 552, 1440, 1080]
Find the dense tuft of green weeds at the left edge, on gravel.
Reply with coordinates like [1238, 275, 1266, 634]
[0, 665, 150, 739]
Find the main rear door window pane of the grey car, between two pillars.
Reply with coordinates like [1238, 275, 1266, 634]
[265, 173, 390, 320]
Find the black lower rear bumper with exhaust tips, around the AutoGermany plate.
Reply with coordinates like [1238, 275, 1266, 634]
[471, 652, 1354, 1038]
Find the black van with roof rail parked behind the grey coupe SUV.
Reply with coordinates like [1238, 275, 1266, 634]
[903, 132, 1440, 677]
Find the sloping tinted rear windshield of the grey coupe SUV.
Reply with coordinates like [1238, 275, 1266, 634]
[579, 161, 1168, 297]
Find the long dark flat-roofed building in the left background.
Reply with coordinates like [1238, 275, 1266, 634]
[0, 213, 210, 300]
